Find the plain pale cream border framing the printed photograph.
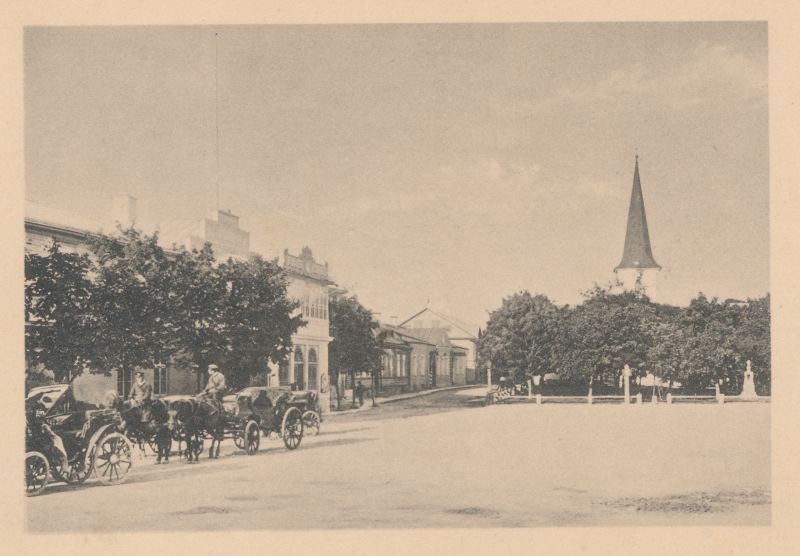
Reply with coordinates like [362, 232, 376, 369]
[0, 0, 800, 556]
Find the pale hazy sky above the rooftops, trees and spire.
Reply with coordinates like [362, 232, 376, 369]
[24, 23, 769, 327]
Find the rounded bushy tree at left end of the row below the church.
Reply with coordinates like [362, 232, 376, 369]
[478, 291, 561, 383]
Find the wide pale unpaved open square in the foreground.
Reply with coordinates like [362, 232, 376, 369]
[26, 388, 771, 532]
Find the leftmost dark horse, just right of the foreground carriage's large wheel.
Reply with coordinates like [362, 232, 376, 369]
[103, 392, 175, 464]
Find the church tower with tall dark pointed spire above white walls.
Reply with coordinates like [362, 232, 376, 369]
[614, 154, 661, 299]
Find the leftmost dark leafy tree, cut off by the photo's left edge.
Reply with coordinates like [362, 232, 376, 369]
[25, 241, 95, 382]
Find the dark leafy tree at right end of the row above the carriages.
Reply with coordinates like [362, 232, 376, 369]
[216, 255, 306, 388]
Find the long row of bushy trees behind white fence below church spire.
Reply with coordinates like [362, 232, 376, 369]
[479, 287, 770, 392]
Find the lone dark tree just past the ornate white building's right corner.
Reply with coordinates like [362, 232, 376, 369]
[328, 294, 383, 404]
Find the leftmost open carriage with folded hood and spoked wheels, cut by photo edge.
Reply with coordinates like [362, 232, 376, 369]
[25, 384, 133, 496]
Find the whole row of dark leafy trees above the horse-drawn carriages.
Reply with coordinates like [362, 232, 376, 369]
[25, 228, 305, 387]
